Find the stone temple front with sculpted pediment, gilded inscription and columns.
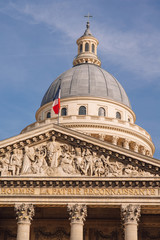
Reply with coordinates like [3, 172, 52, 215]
[0, 125, 160, 240]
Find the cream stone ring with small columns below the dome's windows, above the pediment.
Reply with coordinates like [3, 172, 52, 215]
[22, 116, 155, 156]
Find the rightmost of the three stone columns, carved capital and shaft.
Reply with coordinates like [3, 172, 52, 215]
[121, 204, 140, 240]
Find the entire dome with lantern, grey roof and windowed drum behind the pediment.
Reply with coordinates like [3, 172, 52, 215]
[22, 22, 155, 156]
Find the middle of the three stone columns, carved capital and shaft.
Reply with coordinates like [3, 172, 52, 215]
[68, 204, 87, 240]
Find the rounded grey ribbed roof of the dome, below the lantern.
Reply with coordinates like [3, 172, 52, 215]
[41, 63, 131, 108]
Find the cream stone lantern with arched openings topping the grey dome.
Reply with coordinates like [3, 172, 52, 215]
[73, 16, 101, 66]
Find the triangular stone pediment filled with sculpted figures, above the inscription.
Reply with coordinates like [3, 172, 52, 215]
[0, 124, 160, 178]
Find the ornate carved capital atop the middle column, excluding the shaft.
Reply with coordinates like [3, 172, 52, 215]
[67, 204, 87, 223]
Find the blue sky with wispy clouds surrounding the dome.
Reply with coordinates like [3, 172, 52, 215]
[0, 0, 160, 159]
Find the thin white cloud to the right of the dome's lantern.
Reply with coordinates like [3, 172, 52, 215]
[97, 26, 160, 81]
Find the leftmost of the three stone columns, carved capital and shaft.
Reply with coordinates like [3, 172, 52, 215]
[15, 204, 34, 240]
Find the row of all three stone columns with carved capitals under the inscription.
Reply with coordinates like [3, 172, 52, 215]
[15, 204, 141, 240]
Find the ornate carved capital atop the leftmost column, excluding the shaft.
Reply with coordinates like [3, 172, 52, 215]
[15, 203, 34, 222]
